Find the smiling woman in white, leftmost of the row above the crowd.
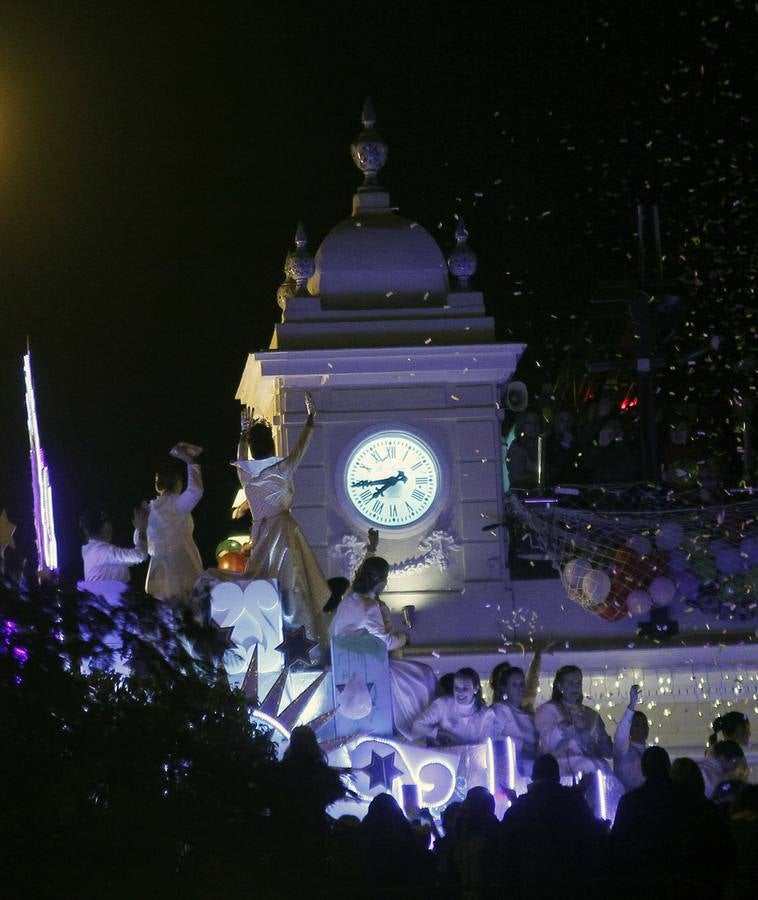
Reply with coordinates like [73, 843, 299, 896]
[412, 667, 492, 747]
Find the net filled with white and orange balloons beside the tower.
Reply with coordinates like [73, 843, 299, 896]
[508, 495, 758, 622]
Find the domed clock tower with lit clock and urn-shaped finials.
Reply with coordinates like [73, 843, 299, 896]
[237, 103, 524, 652]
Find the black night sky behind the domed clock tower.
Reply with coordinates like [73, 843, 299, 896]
[0, 0, 758, 572]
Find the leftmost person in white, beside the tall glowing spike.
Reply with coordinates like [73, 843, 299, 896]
[79, 507, 147, 584]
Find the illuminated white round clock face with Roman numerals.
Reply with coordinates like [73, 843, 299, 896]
[345, 431, 440, 528]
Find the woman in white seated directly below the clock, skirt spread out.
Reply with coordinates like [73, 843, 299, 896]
[329, 556, 437, 738]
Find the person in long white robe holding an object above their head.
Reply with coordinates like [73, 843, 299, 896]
[145, 444, 203, 603]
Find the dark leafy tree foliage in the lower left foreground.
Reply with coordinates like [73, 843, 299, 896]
[0, 583, 275, 897]
